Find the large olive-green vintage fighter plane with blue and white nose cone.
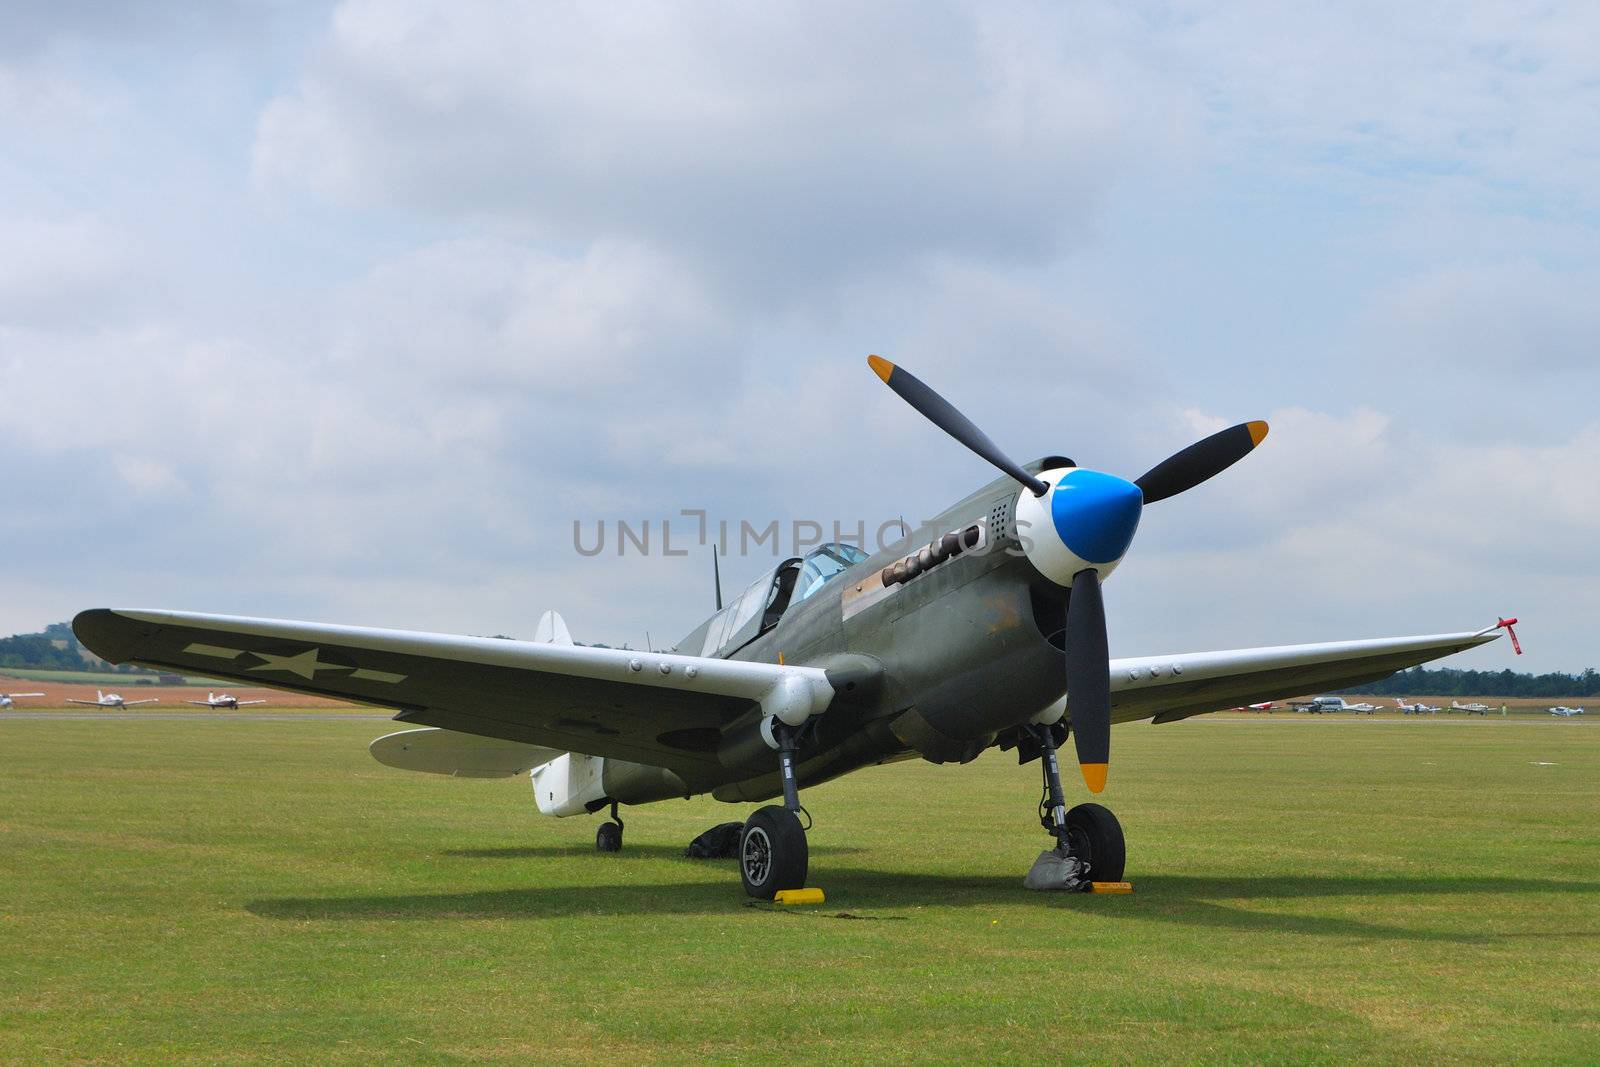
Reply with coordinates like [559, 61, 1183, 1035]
[72, 357, 1514, 897]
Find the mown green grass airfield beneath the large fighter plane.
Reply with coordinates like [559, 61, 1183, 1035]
[0, 717, 1600, 1064]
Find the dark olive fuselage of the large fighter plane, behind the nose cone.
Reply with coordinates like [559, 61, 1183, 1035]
[605, 458, 1067, 803]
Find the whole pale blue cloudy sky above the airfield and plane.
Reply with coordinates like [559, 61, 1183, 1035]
[0, 0, 1600, 670]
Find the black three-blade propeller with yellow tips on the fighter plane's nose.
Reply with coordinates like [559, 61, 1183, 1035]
[867, 355, 1267, 793]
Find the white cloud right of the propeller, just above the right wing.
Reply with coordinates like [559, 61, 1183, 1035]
[1107, 411, 1600, 667]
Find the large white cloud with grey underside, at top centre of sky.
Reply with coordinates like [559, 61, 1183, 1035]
[254, 2, 1168, 292]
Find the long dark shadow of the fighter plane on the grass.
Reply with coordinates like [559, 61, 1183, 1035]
[246, 870, 1600, 944]
